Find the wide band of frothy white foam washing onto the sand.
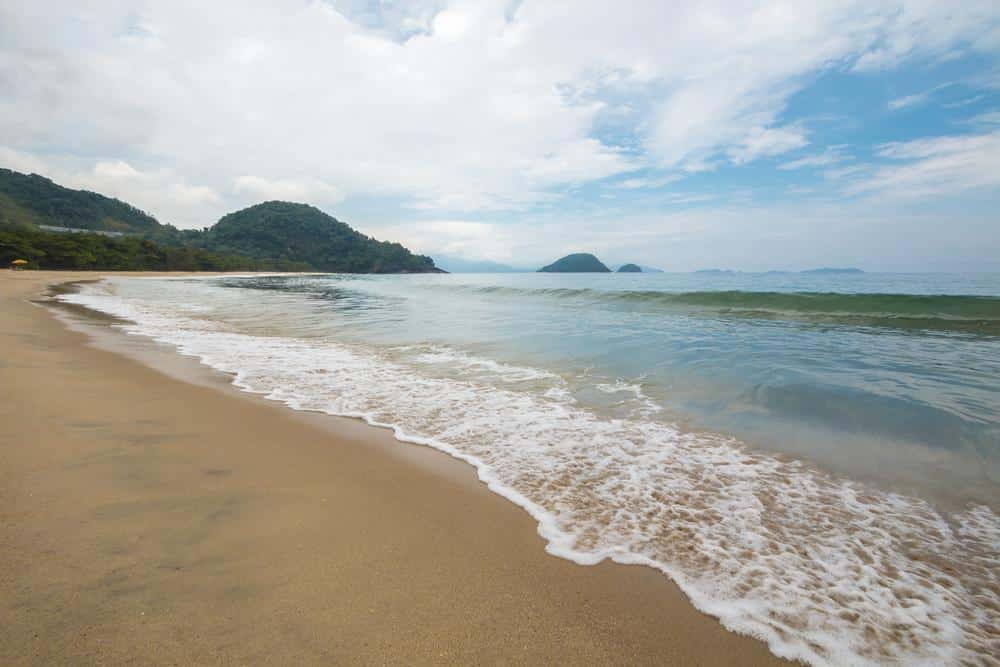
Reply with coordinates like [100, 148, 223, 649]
[61, 285, 1000, 665]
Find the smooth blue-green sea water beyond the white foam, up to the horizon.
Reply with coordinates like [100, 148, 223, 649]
[219, 274, 1000, 507]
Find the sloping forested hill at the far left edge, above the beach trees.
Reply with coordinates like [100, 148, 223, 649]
[0, 169, 160, 234]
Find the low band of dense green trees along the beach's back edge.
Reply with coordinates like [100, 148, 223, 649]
[0, 223, 258, 271]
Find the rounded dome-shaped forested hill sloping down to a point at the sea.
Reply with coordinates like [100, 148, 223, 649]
[204, 201, 440, 273]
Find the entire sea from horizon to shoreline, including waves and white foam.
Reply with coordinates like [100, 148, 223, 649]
[60, 273, 1000, 665]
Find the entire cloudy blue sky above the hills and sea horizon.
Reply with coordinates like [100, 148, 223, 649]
[0, 0, 1000, 271]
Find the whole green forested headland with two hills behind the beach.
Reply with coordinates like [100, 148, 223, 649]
[0, 169, 443, 273]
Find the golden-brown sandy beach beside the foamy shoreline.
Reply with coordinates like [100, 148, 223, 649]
[0, 271, 780, 665]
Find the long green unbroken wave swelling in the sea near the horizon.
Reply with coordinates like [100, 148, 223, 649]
[427, 284, 1000, 336]
